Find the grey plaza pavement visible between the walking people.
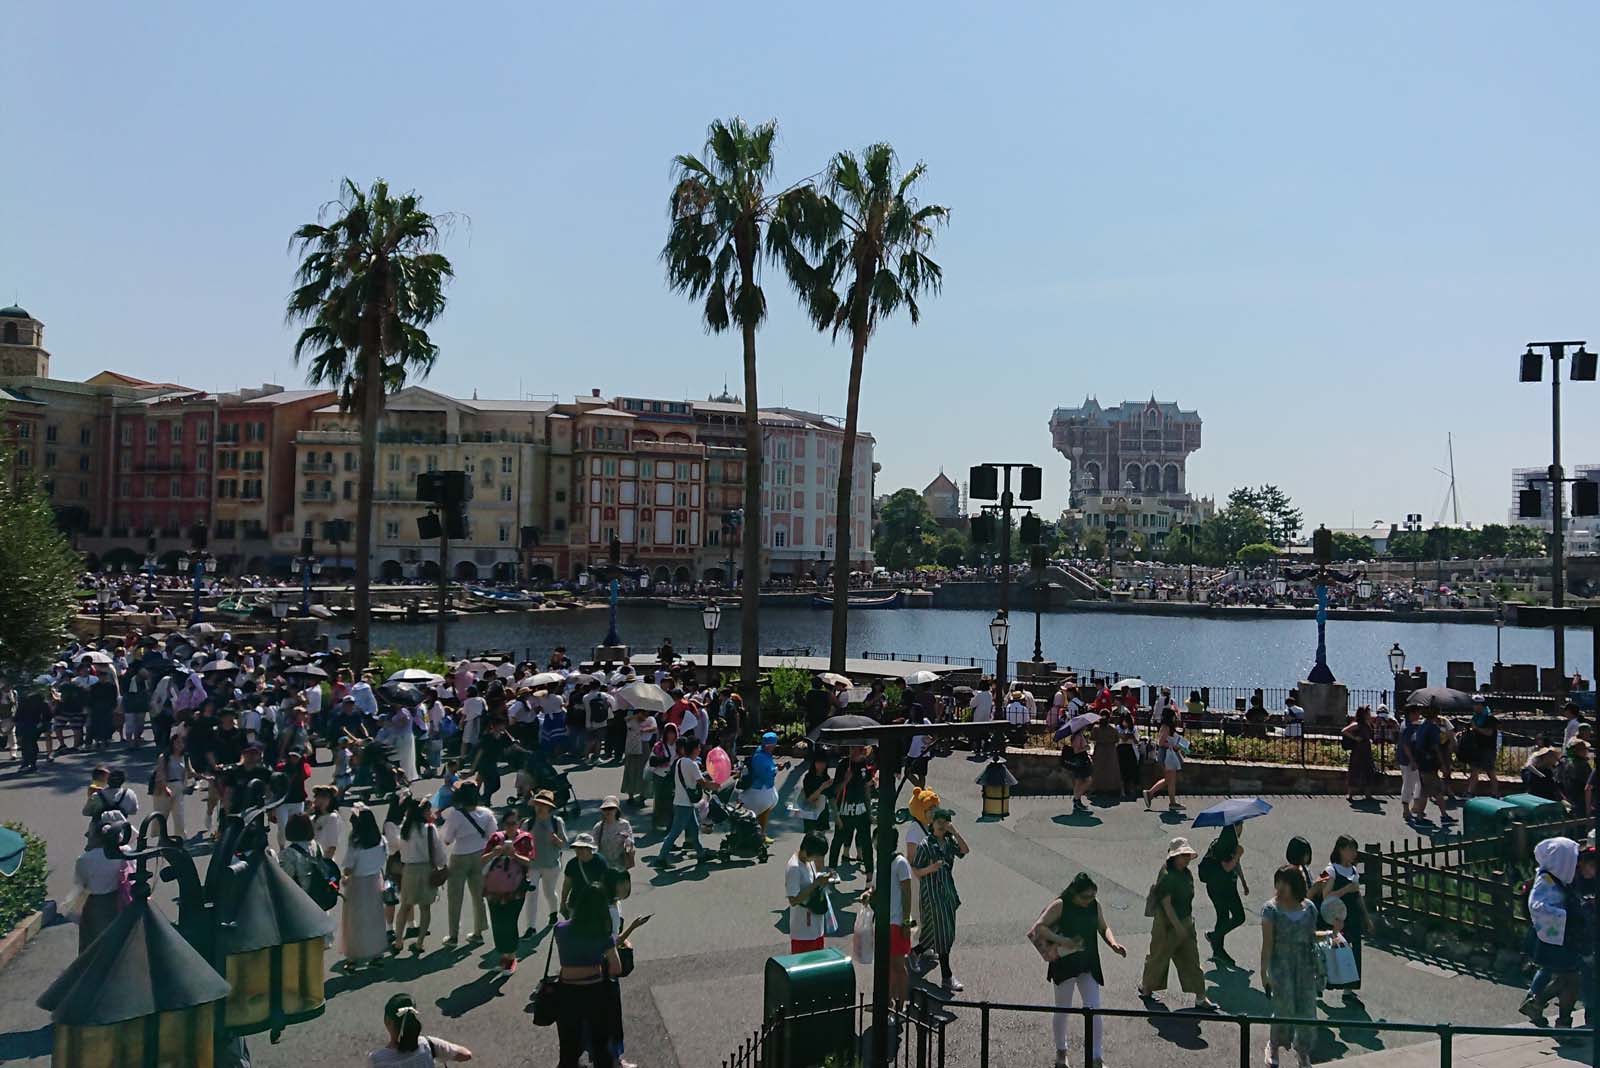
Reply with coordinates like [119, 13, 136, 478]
[0, 748, 1574, 1068]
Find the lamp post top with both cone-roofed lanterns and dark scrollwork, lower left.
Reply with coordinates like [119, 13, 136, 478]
[38, 779, 333, 1068]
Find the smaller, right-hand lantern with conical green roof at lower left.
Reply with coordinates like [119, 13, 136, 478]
[219, 854, 333, 1034]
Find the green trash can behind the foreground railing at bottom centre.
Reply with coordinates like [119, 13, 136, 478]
[762, 950, 856, 1068]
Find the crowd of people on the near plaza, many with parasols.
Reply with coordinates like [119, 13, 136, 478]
[5, 633, 1595, 1068]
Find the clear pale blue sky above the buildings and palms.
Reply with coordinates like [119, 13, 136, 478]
[0, 0, 1600, 526]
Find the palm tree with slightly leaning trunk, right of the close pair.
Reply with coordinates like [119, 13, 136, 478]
[782, 142, 950, 671]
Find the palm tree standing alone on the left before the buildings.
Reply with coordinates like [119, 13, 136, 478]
[285, 177, 454, 671]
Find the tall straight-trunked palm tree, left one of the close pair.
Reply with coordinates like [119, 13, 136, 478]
[661, 117, 812, 710]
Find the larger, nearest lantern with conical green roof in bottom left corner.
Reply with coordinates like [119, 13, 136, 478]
[38, 895, 229, 1068]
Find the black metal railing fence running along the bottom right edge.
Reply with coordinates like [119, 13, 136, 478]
[722, 988, 1595, 1068]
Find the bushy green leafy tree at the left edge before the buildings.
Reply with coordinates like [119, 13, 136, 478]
[0, 452, 83, 675]
